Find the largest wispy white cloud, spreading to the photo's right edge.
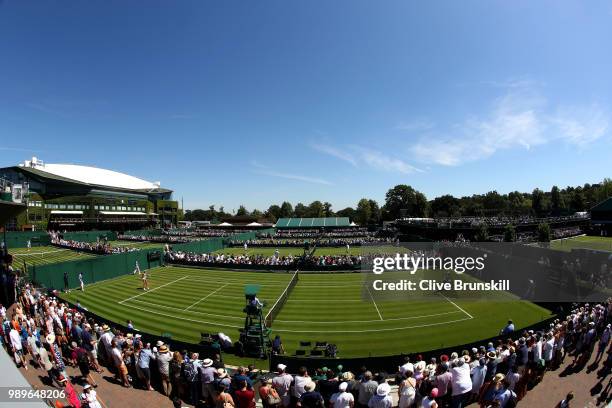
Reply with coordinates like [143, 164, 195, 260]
[410, 85, 609, 166]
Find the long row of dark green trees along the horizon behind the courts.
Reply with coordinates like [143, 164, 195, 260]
[184, 178, 612, 225]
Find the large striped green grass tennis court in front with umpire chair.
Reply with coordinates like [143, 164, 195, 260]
[62, 267, 550, 364]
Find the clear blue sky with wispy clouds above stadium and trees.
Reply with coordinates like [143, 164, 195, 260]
[0, 0, 612, 214]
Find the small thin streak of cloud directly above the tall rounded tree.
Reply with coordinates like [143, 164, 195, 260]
[310, 143, 422, 174]
